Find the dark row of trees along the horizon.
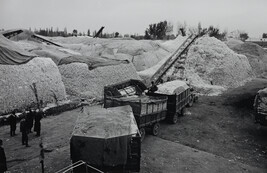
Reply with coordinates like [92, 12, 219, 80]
[30, 20, 252, 41]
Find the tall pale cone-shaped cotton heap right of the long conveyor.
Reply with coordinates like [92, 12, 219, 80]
[185, 37, 254, 94]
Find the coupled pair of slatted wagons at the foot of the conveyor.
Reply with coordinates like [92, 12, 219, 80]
[104, 80, 197, 141]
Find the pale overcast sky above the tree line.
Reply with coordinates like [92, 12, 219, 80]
[0, 0, 267, 37]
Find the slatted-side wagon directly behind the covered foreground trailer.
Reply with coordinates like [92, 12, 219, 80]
[104, 79, 167, 141]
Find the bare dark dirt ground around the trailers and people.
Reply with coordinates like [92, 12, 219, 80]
[0, 79, 267, 173]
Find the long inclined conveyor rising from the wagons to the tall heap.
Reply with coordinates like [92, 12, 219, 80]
[150, 34, 199, 85]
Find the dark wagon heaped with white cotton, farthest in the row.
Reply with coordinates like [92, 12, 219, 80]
[147, 80, 197, 124]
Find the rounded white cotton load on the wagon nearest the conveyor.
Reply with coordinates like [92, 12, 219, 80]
[156, 80, 189, 95]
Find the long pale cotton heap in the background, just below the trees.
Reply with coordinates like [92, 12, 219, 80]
[52, 37, 170, 71]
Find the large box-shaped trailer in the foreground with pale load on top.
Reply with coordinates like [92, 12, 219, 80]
[70, 106, 141, 172]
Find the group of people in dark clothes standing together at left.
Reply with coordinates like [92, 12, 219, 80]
[8, 109, 43, 147]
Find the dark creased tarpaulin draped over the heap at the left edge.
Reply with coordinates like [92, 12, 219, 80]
[0, 34, 36, 65]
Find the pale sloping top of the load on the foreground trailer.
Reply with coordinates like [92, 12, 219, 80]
[73, 106, 138, 139]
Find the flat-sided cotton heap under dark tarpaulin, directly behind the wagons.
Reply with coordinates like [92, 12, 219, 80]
[58, 63, 140, 99]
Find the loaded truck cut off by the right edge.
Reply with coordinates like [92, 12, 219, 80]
[253, 88, 267, 126]
